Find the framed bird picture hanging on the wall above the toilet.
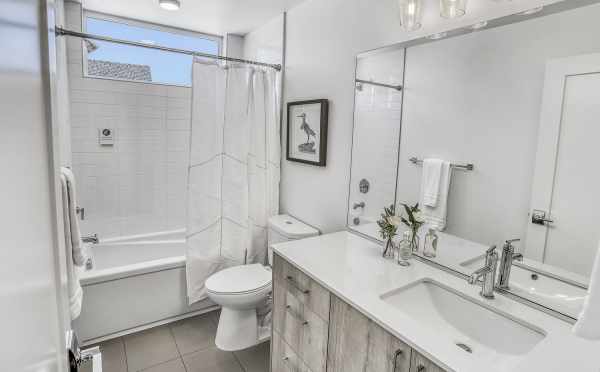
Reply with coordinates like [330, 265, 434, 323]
[286, 99, 329, 167]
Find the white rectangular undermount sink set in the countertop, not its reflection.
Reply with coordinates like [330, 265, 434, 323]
[380, 279, 545, 360]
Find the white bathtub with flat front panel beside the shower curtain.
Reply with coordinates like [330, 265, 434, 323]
[74, 230, 217, 345]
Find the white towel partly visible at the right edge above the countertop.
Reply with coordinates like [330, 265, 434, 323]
[573, 243, 600, 340]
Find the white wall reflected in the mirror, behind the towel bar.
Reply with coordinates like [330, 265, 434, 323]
[397, 4, 600, 250]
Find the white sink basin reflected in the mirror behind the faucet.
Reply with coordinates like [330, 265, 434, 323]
[461, 257, 587, 318]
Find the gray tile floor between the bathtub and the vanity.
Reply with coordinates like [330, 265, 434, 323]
[86, 312, 269, 372]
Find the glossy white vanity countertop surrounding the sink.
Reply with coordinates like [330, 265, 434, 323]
[273, 231, 600, 372]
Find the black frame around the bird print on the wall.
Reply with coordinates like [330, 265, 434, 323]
[285, 99, 329, 167]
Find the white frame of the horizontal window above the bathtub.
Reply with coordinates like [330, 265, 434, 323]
[81, 10, 223, 88]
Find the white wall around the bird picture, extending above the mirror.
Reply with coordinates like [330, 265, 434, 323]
[281, 0, 572, 232]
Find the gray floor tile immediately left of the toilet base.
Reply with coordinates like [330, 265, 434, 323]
[170, 313, 217, 355]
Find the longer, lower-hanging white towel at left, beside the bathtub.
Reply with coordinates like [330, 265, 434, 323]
[60, 173, 83, 320]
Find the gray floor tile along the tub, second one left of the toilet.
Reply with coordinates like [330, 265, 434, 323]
[123, 326, 179, 372]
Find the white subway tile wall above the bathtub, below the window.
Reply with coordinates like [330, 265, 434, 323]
[65, 2, 191, 238]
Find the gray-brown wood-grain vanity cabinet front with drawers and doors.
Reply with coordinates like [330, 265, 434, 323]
[271, 254, 444, 372]
